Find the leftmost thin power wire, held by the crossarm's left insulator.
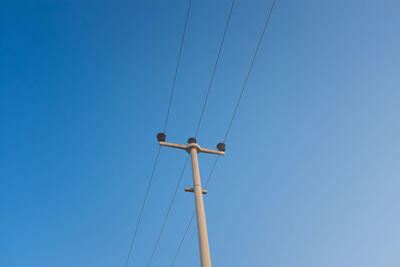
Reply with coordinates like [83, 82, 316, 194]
[125, 0, 192, 267]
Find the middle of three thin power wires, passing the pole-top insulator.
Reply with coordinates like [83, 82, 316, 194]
[148, 0, 235, 266]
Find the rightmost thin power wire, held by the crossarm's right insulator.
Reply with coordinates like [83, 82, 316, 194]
[171, 0, 276, 266]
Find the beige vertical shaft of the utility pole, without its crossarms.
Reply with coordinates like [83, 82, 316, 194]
[190, 148, 211, 267]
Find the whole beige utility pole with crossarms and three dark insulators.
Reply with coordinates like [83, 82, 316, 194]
[157, 133, 225, 267]
